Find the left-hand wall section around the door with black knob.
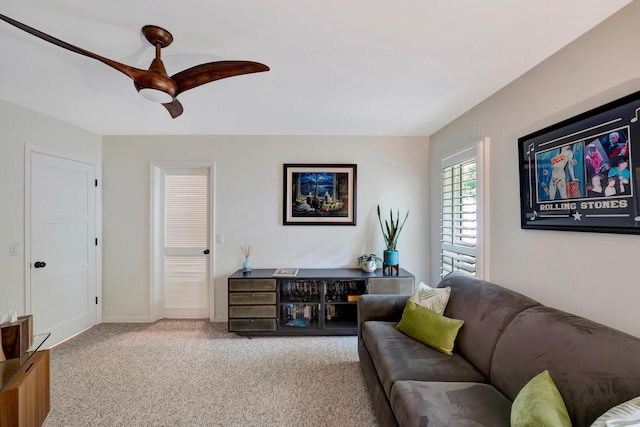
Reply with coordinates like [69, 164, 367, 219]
[0, 100, 102, 315]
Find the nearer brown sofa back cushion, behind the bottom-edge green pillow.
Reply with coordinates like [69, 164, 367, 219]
[490, 306, 640, 426]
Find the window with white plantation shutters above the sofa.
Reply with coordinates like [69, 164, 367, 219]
[440, 138, 488, 279]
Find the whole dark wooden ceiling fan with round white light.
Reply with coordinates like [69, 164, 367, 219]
[0, 14, 269, 119]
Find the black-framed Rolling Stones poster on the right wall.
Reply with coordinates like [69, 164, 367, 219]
[518, 92, 640, 234]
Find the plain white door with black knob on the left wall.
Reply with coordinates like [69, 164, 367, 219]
[27, 151, 97, 345]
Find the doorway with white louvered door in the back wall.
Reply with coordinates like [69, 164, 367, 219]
[150, 163, 213, 321]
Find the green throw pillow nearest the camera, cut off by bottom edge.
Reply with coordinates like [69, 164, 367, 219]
[511, 370, 571, 427]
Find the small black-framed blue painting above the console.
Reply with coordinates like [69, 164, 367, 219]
[283, 164, 357, 225]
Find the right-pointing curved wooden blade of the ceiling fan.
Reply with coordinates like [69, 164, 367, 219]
[171, 61, 269, 93]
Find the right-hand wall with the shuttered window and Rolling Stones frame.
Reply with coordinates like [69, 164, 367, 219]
[430, 2, 640, 336]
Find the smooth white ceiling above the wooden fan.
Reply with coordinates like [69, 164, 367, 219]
[0, 0, 631, 136]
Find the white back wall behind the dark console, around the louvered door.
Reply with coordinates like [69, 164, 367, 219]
[103, 136, 430, 321]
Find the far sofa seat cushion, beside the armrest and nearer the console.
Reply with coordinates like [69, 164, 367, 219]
[362, 321, 486, 397]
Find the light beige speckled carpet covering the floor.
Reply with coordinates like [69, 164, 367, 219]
[44, 320, 378, 427]
